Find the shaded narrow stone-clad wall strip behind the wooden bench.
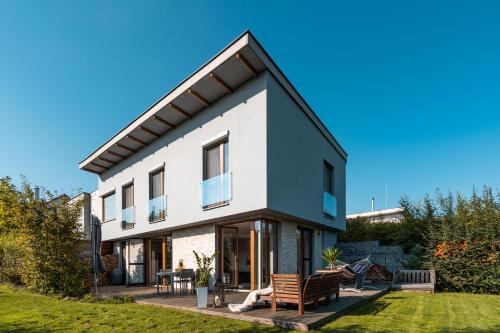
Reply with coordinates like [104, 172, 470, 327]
[278, 222, 297, 274]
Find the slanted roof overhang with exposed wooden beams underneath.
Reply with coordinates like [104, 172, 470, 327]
[79, 31, 347, 174]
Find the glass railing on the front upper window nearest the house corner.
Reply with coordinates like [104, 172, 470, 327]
[200, 172, 232, 208]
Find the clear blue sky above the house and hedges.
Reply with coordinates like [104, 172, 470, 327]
[0, 0, 500, 212]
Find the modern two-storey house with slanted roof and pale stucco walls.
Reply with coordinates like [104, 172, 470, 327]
[79, 32, 347, 289]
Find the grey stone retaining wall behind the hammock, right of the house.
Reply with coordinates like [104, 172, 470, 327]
[337, 241, 408, 273]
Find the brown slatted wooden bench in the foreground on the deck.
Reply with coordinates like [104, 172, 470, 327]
[271, 271, 342, 315]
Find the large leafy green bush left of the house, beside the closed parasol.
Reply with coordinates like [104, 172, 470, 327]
[20, 184, 88, 296]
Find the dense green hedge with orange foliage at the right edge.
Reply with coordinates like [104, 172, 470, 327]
[402, 188, 500, 294]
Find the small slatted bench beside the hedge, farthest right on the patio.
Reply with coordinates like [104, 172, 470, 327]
[391, 269, 436, 293]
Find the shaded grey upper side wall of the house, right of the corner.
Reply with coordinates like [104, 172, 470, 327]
[267, 76, 346, 230]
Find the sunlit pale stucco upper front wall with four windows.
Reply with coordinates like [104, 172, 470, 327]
[97, 73, 267, 240]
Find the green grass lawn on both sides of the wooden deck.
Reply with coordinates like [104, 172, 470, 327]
[0, 285, 500, 333]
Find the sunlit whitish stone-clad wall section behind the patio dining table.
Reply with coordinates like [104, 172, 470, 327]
[172, 224, 216, 271]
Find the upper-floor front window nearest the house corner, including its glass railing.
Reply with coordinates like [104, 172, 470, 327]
[201, 139, 232, 209]
